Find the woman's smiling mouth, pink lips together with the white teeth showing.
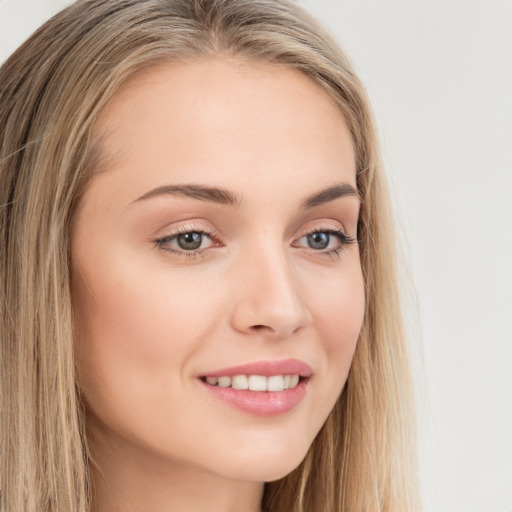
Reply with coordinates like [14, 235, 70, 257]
[200, 359, 312, 416]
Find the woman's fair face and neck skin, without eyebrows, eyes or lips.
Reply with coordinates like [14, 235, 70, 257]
[72, 57, 364, 512]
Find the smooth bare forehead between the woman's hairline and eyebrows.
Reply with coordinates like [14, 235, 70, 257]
[91, 58, 356, 203]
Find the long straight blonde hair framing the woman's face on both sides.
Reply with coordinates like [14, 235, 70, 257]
[0, 0, 418, 512]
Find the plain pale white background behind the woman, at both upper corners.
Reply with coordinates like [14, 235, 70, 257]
[0, 0, 512, 512]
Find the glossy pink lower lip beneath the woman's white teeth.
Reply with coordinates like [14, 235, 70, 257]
[201, 379, 308, 416]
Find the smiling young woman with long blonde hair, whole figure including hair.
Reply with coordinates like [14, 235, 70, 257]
[0, 0, 417, 512]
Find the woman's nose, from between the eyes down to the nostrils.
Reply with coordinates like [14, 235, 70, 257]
[231, 245, 313, 338]
